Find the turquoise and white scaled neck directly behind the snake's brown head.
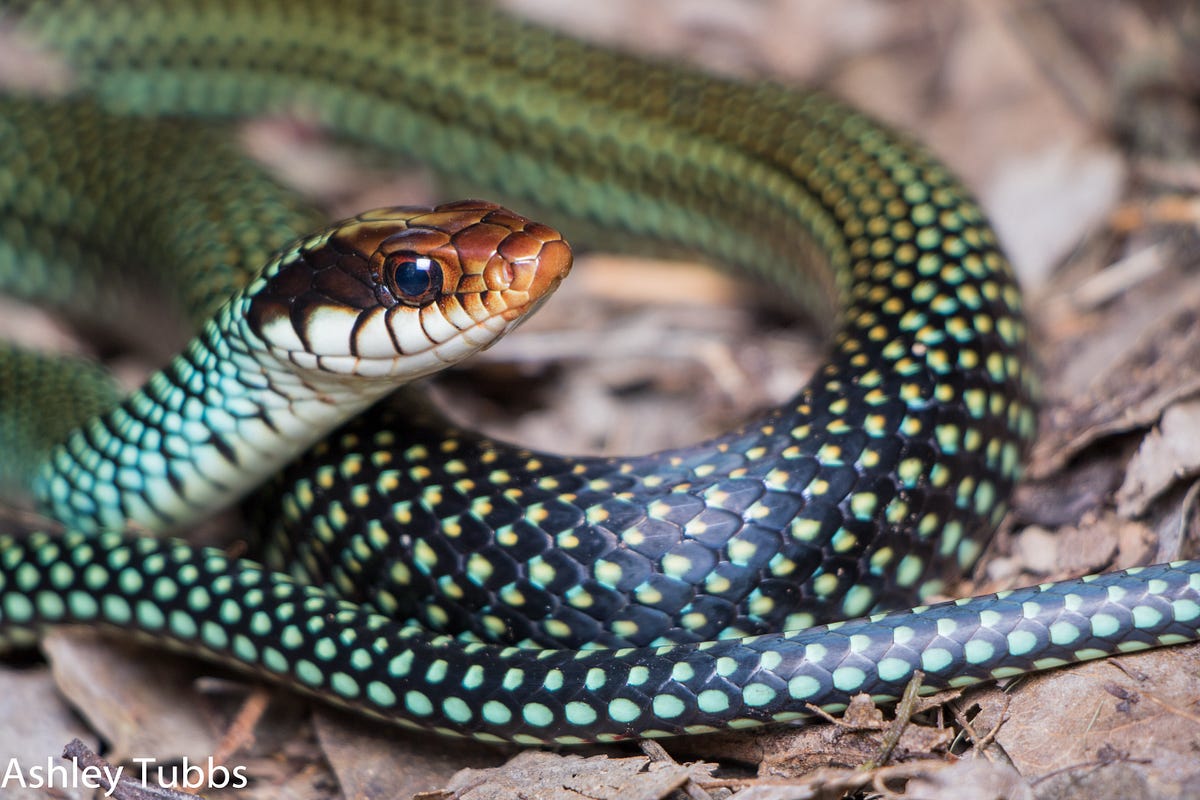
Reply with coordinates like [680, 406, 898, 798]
[31, 293, 395, 531]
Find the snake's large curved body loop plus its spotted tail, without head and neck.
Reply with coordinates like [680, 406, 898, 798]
[0, 0, 1200, 744]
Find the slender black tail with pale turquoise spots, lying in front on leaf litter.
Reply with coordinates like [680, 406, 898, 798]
[0, 533, 1200, 745]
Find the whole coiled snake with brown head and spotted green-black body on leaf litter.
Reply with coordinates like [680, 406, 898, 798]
[0, 0, 1200, 745]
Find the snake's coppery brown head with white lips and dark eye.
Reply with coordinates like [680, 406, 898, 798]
[245, 200, 571, 381]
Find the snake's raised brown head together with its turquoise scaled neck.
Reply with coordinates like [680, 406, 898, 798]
[12, 190, 571, 530]
